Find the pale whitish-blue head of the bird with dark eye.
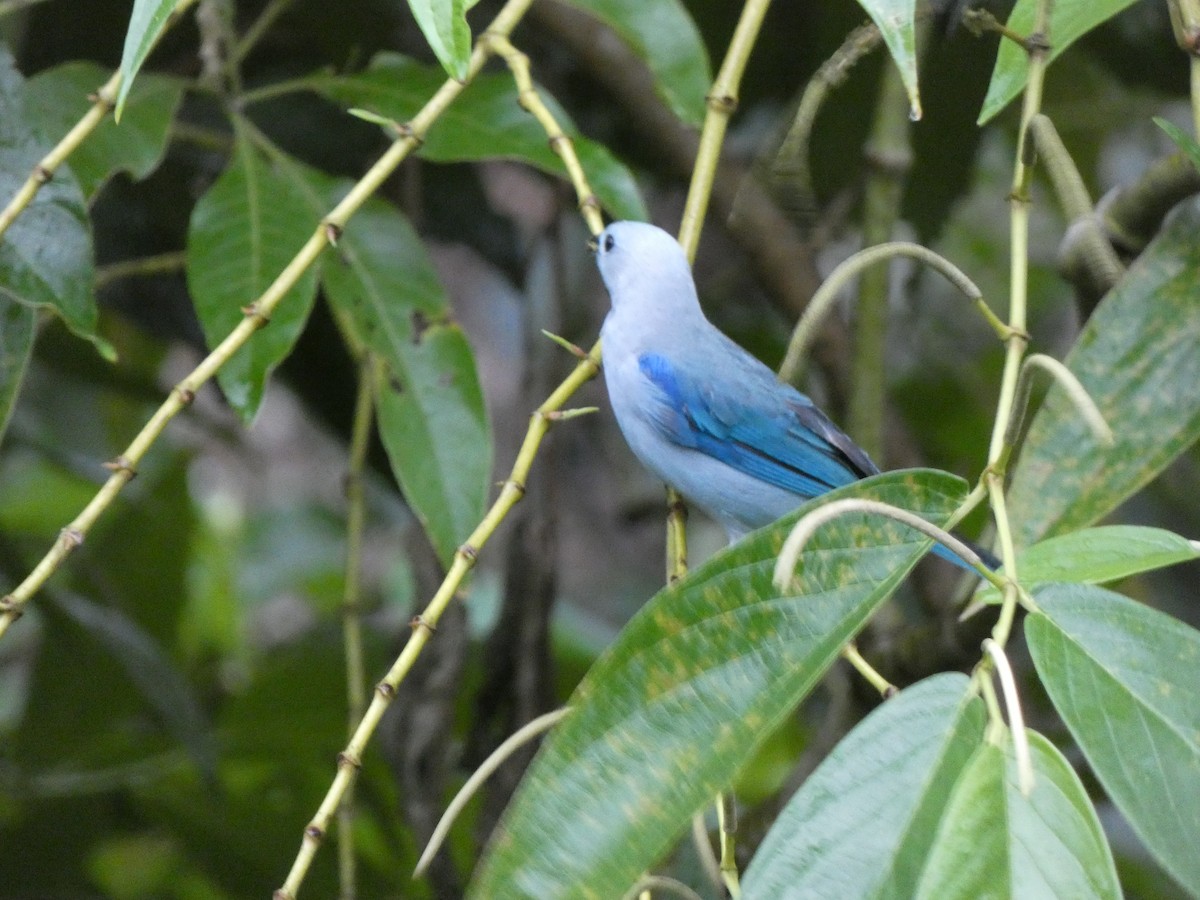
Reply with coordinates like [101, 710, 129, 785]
[595, 222, 700, 316]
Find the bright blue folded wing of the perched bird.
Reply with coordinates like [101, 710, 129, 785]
[638, 344, 878, 498]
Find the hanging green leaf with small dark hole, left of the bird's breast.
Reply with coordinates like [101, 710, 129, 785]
[324, 186, 492, 565]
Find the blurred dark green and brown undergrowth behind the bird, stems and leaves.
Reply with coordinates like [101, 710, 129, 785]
[0, 0, 1200, 899]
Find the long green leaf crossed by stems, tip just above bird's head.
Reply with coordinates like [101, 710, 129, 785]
[310, 53, 648, 220]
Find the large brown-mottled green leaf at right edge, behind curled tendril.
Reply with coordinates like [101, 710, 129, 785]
[1009, 200, 1200, 545]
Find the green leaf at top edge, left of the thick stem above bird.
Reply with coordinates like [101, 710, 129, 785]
[569, 0, 713, 126]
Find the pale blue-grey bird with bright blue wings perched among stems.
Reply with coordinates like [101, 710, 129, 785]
[593, 221, 988, 569]
